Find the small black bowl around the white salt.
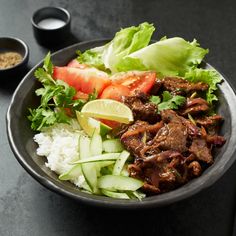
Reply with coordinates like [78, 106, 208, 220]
[31, 7, 71, 46]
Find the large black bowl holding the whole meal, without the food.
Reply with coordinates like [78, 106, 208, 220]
[7, 40, 236, 209]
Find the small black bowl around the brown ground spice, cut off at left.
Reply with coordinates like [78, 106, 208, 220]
[0, 37, 29, 79]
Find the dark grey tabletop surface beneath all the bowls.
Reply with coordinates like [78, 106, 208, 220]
[0, 0, 236, 236]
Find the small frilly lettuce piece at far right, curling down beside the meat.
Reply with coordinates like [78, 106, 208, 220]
[185, 68, 222, 104]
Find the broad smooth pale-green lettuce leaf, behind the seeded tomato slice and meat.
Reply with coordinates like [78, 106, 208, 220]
[116, 37, 208, 76]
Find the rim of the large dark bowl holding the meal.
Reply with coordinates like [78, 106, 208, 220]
[6, 39, 236, 209]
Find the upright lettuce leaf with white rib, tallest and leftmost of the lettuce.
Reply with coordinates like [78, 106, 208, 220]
[77, 22, 155, 73]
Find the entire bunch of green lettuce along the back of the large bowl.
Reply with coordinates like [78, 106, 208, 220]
[77, 22, 221, 104]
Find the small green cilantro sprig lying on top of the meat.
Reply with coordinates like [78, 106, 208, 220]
[150, 91, 186, 112]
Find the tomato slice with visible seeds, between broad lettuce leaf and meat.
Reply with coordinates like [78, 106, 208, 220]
[111, 71, 156, 95]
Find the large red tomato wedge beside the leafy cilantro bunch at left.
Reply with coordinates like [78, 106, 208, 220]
[53, 66, 111, 95]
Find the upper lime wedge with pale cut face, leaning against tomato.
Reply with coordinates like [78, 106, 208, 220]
[81, 99, 134, 124]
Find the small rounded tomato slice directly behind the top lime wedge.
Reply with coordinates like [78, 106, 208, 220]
[100, 84, 130, 101]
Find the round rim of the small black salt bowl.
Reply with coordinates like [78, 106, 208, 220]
[31, 6, 71, 32]
